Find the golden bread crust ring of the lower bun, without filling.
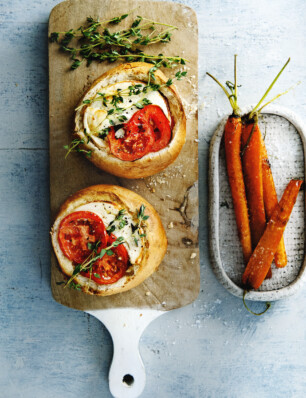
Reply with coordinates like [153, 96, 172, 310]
[51, 185, 167, 296]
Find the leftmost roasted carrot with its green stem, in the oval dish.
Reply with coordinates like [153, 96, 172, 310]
[207, 55, 252, 264]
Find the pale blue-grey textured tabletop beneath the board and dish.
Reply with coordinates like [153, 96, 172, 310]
[0, 0, 306, 398]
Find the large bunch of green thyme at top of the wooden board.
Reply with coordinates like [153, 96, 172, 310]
[50, 14, 187, 70]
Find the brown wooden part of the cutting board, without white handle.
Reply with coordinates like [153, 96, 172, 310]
[49, 0, 200, 311]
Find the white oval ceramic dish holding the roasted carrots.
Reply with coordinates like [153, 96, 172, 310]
[209, 106, 306, 301]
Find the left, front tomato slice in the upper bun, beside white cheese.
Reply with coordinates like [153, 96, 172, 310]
[108, 112, 154, 161]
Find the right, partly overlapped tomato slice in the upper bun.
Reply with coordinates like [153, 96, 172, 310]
[137, 105, 171, 152]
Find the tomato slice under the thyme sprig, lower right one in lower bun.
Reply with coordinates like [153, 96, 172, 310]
[81, 234, 129, 285]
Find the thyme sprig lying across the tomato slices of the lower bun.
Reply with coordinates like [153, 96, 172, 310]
[65, 236, 124, 287]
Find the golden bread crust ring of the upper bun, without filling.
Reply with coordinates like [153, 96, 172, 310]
[74, 62, 186, 179]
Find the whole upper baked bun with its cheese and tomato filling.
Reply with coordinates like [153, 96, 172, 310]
[75, 62, 186, 178]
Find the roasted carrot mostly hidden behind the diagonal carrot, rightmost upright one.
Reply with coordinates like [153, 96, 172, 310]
[261, 136, 287, 268]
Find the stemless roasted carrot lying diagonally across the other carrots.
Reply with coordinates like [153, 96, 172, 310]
[242, 180, 303, 289]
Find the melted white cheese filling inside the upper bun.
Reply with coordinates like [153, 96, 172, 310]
[83, 81, 171, 139]
